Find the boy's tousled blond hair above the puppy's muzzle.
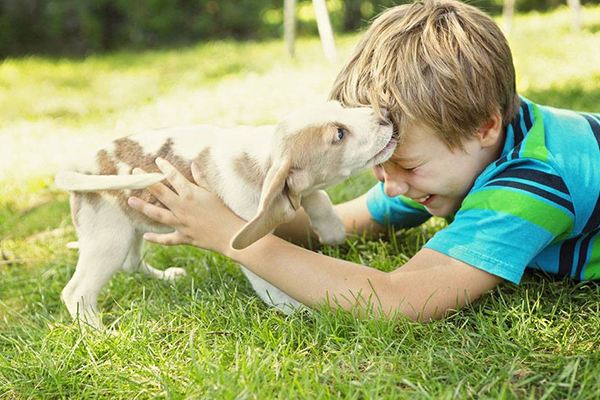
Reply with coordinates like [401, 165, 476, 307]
[330, 0, 519, 149]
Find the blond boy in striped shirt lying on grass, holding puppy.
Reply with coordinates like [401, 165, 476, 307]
[130, 0, 600, 320]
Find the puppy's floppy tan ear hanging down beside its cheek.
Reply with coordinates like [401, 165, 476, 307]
[231, 158, 300, 250]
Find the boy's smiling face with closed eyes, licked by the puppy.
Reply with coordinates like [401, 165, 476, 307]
[374, 120, 502, 217]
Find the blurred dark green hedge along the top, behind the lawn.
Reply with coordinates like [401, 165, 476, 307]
[0, 0, 600, 57]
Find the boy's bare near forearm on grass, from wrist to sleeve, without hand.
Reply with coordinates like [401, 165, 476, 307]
[226, 235, 501, 321]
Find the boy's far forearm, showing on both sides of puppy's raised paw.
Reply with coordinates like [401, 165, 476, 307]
[275, 194, 386, 247]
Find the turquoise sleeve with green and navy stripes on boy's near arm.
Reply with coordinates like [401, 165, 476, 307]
[425, 163, 575, 284]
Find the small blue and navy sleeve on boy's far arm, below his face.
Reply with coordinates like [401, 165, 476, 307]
[367, 182, 431, 228]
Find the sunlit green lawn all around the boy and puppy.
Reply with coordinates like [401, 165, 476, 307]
[0, 7, 600, 399]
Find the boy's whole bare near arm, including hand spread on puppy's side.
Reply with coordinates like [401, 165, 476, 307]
[129, 160, 500, 320]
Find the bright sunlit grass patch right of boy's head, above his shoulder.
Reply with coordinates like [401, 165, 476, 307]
[510, 8, 600, 112]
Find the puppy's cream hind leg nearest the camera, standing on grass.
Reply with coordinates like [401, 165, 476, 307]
[61, 202, 134, 329]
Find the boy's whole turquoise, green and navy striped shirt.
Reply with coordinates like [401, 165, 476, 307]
[367, 98, 600, 283]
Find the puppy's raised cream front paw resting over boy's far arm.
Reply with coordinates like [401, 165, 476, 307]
[301, 190, 346, 245]
